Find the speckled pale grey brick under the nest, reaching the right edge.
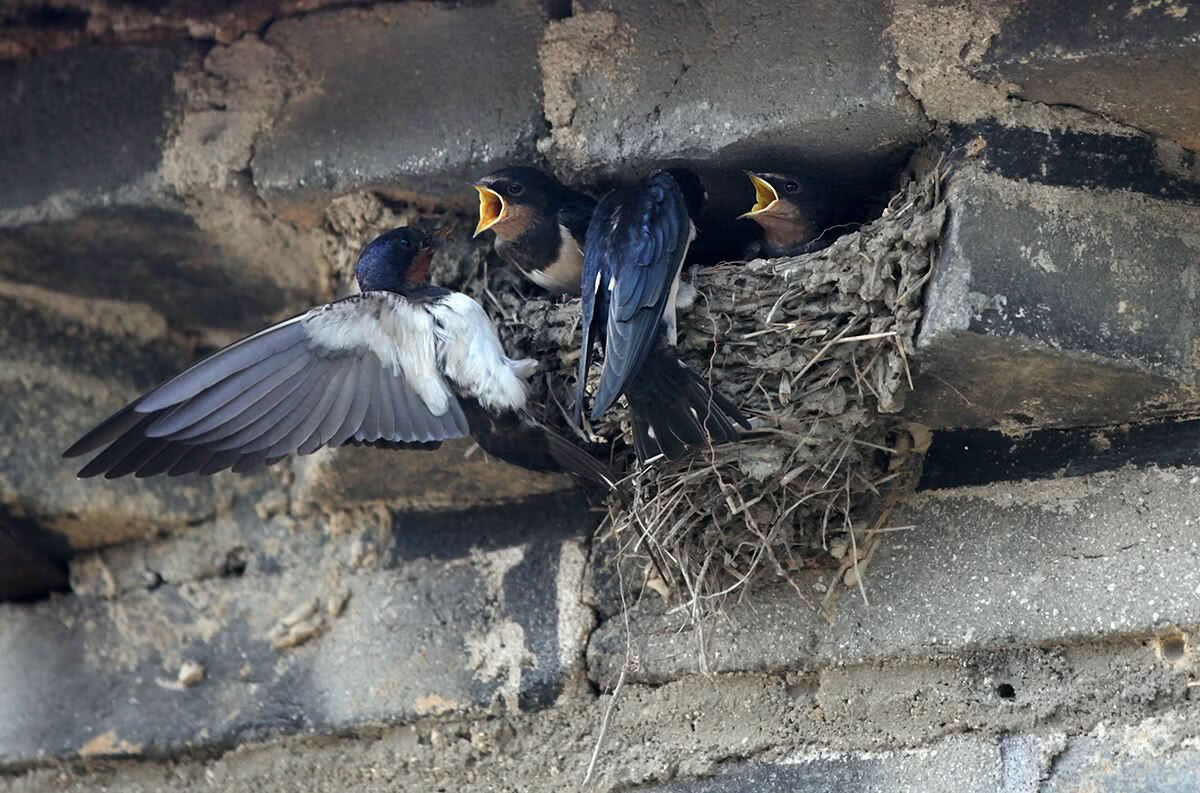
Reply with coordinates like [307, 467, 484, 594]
[589, 468, 1200, 681]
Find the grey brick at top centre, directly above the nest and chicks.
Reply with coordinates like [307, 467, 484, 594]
[542, 0, 928, 176]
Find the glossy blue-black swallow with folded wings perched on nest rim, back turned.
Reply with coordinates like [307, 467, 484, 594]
[575, 169, 750, 461]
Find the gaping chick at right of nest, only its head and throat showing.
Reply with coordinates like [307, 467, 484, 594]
[740, 170, 832, 258]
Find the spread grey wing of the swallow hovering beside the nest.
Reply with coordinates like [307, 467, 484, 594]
[65, 292, 472, 479]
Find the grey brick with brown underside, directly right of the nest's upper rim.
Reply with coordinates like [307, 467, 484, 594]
[908, 130, 1200, 428]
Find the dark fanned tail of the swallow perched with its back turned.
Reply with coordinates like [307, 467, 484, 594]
[625, 347, 750, 461]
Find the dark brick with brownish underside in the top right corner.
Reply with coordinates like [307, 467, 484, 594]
[972, 0, 1200, 149]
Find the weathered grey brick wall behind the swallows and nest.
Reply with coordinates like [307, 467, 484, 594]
[0, 0, 1200, 793]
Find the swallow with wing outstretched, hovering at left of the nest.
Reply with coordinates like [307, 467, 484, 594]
[65, 228, 608, 483]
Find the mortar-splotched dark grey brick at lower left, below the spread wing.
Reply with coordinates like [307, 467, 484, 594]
[0, 491, 590, 764]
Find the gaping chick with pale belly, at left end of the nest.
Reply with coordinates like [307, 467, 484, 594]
[475, 166, 596, 294]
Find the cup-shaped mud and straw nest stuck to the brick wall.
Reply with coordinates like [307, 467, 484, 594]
[458, 169, 946, 612]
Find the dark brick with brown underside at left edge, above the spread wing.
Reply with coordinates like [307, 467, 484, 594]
[0, 43, 317, 332]
